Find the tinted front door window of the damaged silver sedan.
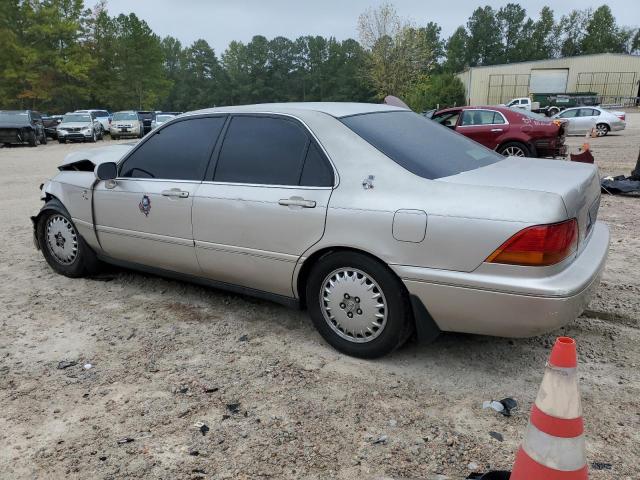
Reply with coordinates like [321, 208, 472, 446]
[120, 117, 225, 180]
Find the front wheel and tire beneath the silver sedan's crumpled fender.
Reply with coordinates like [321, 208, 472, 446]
[36, 200, 99, 278]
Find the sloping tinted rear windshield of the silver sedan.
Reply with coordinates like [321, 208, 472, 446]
[341, 111, 504, 180]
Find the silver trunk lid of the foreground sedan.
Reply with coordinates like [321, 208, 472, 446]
[436, 157, 600, 249]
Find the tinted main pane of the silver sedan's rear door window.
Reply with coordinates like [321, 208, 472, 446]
[214, 116, 309, 185]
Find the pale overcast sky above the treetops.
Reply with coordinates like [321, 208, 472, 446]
[85, 0, 640, 55]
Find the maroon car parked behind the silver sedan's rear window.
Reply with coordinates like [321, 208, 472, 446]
[431, 107, 567, 157]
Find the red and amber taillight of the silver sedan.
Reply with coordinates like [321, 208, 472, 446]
[485, 218, 578, 266]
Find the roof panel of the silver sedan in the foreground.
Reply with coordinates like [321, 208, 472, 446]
[189, 102, 407, 118]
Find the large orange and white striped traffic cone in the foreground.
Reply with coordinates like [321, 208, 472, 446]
[510, 337, 589, 480]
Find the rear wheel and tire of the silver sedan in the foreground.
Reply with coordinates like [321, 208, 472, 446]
[305, 252, 413, 358]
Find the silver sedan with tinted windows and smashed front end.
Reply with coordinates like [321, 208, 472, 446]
[32, 103, 609, 358]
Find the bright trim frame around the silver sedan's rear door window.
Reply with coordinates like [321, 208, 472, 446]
[202, 112, 340, 190]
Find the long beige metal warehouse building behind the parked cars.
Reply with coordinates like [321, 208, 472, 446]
[458, 53, 640, 105]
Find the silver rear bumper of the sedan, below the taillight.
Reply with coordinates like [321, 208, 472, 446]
[393, 222, 609, 337]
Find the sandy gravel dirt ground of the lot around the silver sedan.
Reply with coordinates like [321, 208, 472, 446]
[0, 114, 640, 480]
